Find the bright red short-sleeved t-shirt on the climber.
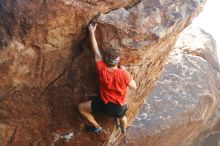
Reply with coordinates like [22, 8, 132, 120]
[96, 60, 132, 106]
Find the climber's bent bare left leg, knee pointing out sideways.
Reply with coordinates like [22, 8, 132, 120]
[79, 100, 100, 128]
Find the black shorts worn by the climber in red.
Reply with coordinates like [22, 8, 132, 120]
[92, 97, 128, 118]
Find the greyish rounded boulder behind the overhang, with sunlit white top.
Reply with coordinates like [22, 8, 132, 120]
[123, 27, 220, 146]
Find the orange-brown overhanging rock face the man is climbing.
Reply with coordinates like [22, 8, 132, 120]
[0, 0, 205, 146]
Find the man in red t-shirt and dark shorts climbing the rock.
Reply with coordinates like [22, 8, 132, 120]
[78, 24, 137, 133]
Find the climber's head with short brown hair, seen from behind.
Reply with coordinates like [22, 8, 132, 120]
[103, 49, 120, 67]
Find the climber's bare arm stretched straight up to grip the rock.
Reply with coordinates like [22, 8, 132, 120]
[89, 24, 102, 62]
